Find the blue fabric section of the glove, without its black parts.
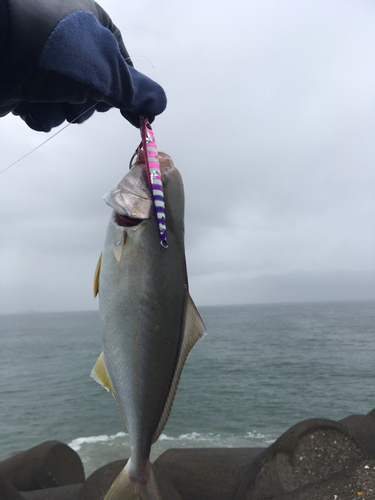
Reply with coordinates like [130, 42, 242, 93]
[38, 11, 167, 124]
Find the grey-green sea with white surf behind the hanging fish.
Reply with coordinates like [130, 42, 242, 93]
[0, 302, 375, 475]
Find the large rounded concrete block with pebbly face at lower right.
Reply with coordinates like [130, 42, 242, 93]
[233, 419, 368, 500]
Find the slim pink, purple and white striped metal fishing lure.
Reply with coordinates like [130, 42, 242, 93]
[141, 118, 168, 248]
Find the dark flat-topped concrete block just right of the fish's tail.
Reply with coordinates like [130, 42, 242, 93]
[155, 448, 264, 500]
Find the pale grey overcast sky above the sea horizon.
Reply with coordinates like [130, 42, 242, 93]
[0, 0, 375, 314]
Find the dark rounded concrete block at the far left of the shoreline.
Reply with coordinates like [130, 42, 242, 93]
[0, 441, 85, 491]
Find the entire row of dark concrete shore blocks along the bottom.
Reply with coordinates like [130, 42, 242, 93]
[0, 410, 375, 500]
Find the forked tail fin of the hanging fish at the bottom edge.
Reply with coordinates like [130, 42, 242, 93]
[104, 459, 162, 500]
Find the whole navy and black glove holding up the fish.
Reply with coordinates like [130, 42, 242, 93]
[0, 0, 166, 132]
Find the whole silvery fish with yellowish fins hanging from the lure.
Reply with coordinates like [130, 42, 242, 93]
[91, 153, 206, 500]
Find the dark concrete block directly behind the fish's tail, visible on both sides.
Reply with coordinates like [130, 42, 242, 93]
[74, 460, 182, 500]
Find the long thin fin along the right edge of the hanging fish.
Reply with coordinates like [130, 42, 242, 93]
[152, 294, 206, 443]
